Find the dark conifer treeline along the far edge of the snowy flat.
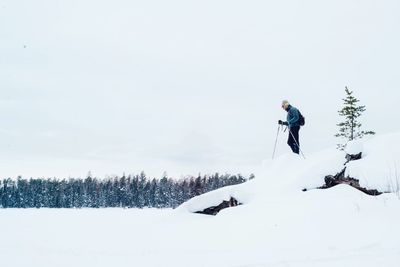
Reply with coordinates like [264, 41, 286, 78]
[0, 173, 254, 208]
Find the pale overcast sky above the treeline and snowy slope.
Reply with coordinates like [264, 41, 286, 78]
[0, 0, 400, 178]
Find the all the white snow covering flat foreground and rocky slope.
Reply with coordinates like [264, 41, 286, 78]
[0, 134, 400, 267]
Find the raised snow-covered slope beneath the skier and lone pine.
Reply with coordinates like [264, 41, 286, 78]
[178, 133, 400, 215]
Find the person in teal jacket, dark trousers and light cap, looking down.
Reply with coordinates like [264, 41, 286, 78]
[278, 100, 300, 154]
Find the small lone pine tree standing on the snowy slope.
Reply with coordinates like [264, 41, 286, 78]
[335, 86, 375, 150]
